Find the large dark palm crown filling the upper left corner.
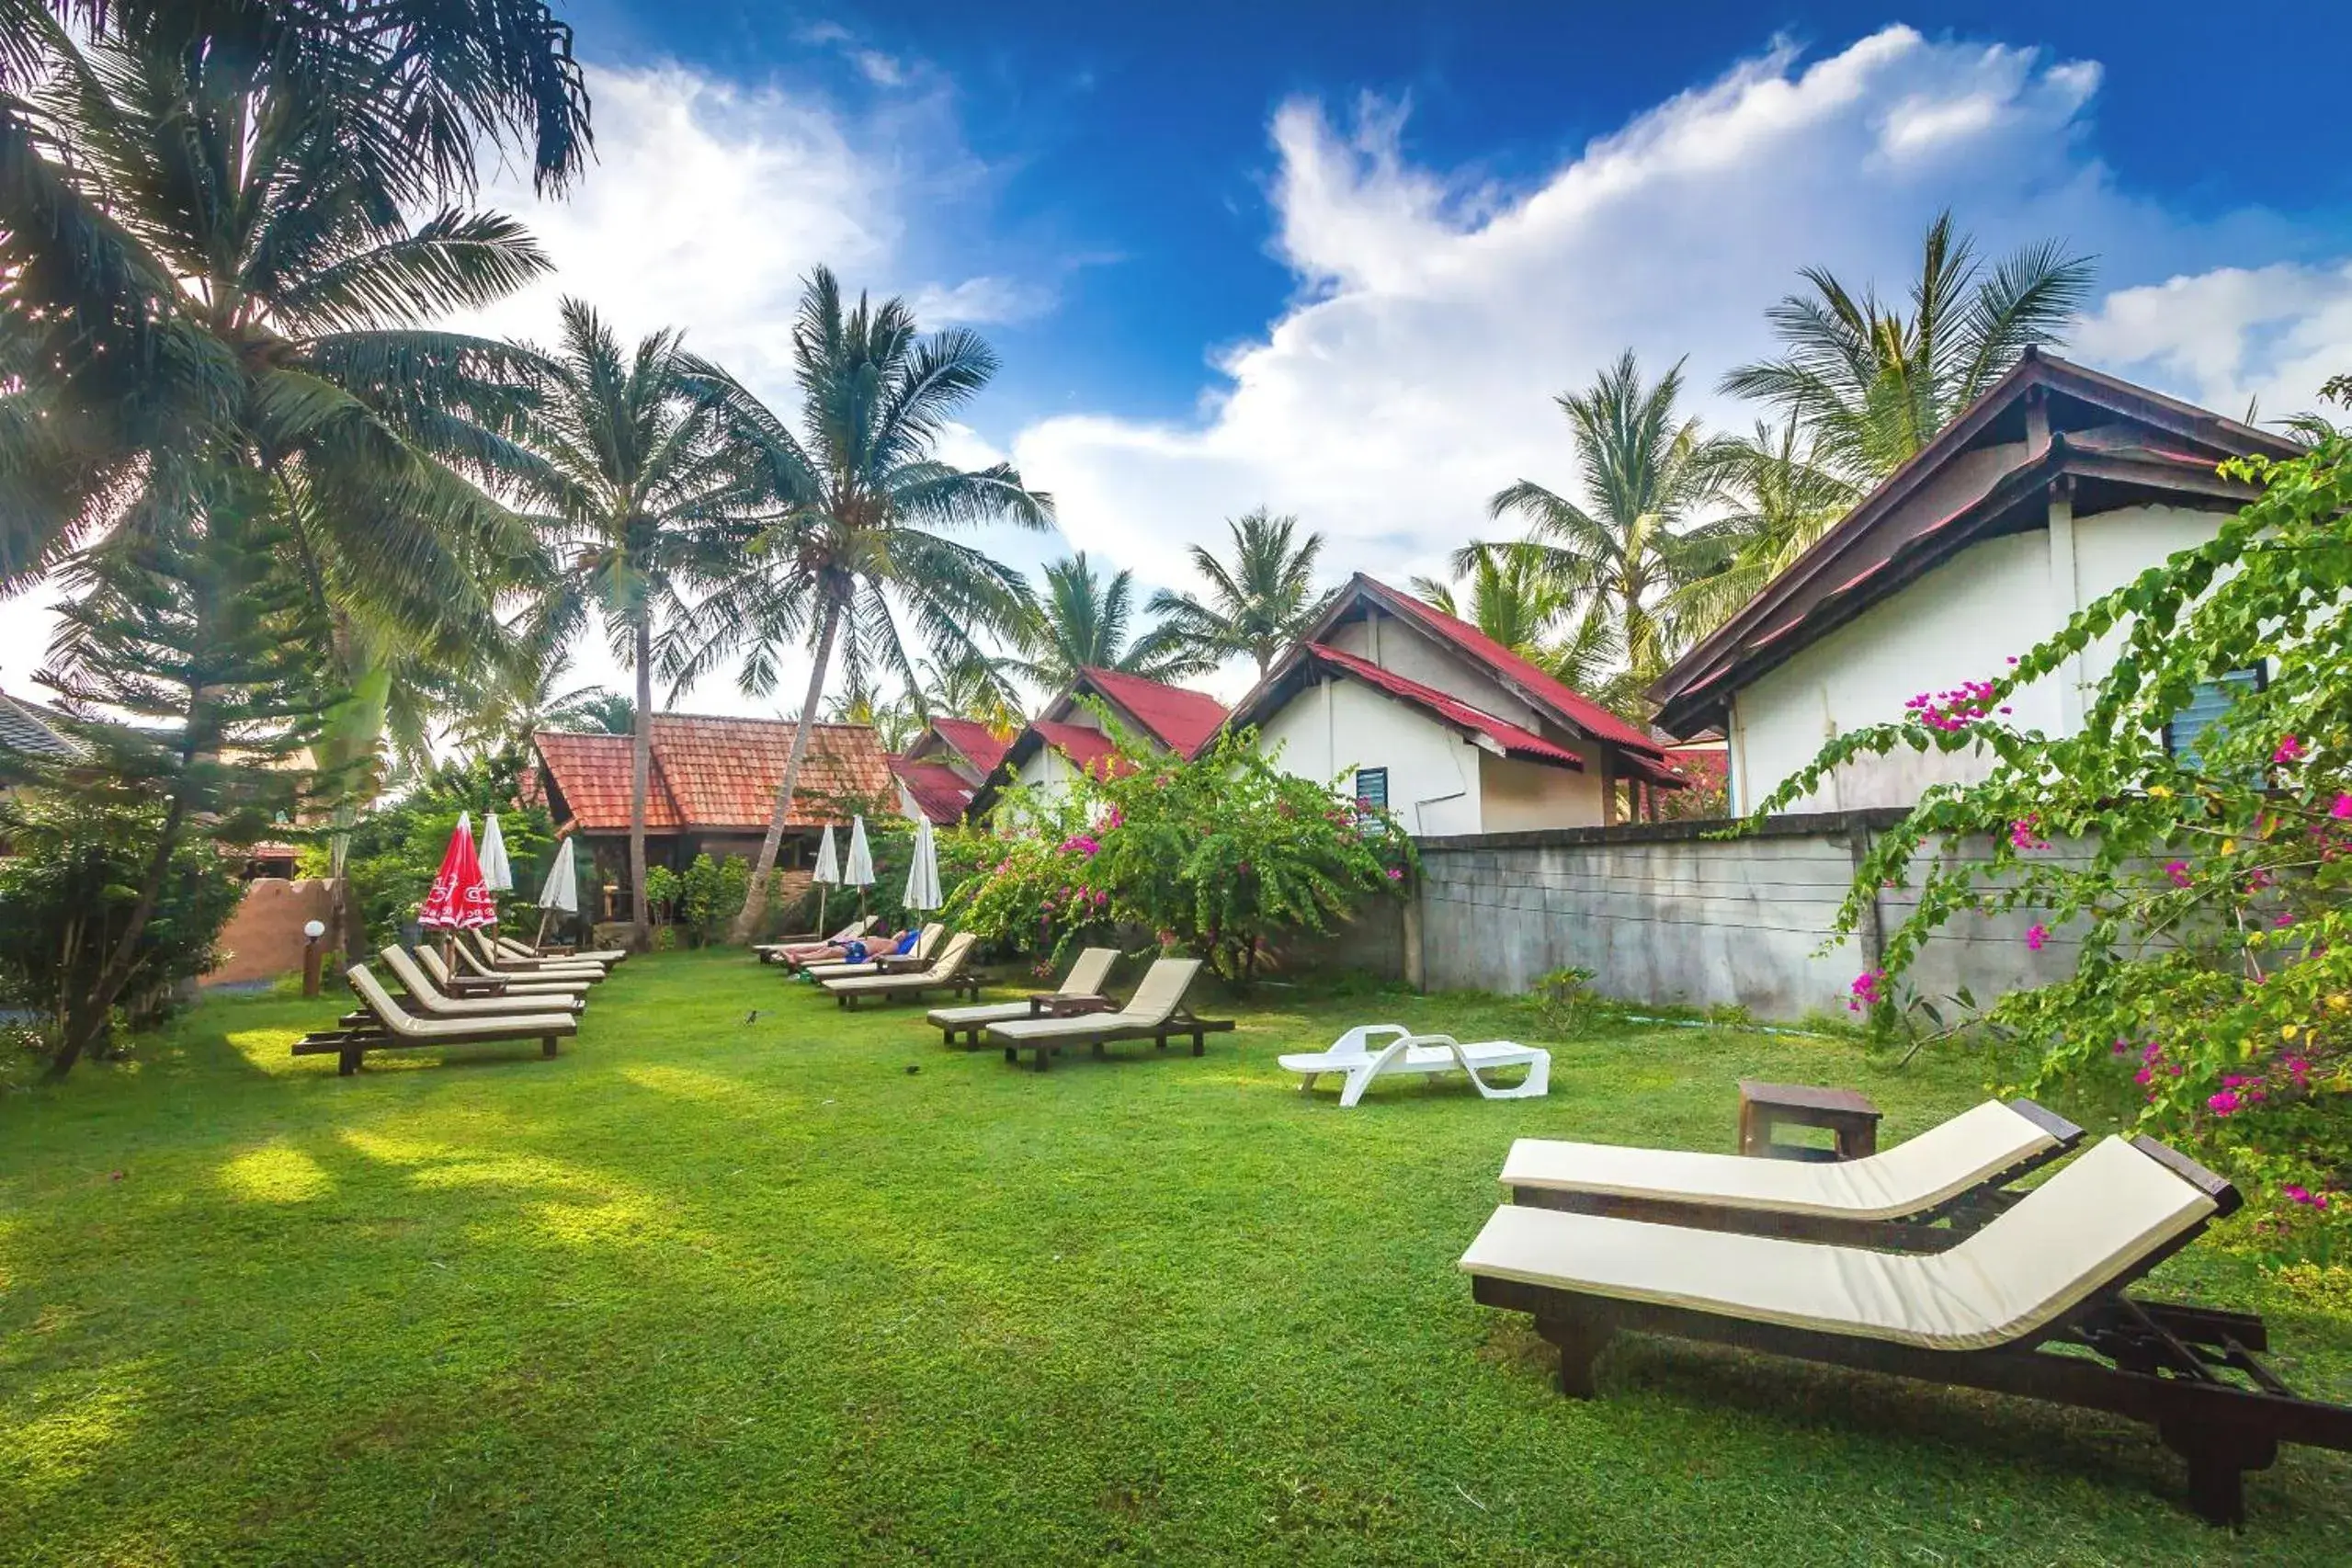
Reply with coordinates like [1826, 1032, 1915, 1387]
[0, 0, 585, 959]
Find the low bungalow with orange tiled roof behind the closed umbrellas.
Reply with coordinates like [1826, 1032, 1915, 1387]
[531, 712, 899, 907]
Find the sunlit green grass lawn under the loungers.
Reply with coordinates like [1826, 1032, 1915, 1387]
[0, 954, 2352, 1565]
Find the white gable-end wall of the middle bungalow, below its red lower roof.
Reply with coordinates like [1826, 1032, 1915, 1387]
[1258, 679, 1486, 835]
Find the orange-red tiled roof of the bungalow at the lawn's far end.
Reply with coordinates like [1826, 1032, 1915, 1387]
[531, 712, 893, 832]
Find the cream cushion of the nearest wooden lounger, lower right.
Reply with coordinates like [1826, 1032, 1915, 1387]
[1460, 1138, 2213, 1349]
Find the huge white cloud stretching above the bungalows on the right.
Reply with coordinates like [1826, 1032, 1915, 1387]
[1014, 28, 2352, 601]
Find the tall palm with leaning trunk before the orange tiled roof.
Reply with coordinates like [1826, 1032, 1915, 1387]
[675, 268, 1053, 943]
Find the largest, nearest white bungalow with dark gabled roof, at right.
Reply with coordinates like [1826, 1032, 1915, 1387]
[1649, 350, 2296, 811]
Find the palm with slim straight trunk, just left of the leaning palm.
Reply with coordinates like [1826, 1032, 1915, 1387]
[512, 299, 753, 948]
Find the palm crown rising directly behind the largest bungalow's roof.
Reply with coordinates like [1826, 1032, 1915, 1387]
[1724, 211, 2094, 484]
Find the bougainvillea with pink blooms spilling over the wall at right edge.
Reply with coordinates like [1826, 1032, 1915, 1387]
[1759, 411, 2352, 1260]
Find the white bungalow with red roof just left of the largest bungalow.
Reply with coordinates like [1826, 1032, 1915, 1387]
[1228, 574, 1688, 837]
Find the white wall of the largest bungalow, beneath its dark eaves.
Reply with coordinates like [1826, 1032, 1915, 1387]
[1729, 506, 2221, 811]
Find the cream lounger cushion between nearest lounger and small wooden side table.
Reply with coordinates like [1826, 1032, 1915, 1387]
[1505, 1100, 2058, 1220]
